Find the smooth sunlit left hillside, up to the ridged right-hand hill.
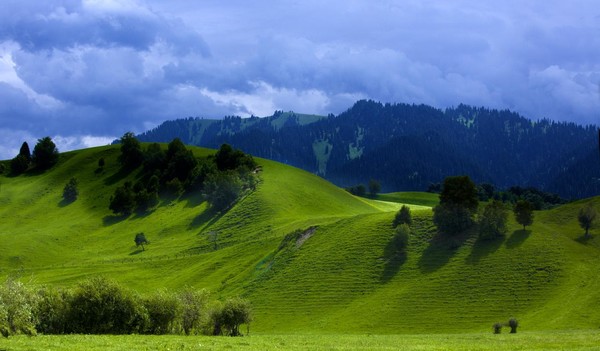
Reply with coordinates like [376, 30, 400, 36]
[0, 147, 384, 293]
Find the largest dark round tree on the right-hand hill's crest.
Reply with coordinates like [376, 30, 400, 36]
[433, 176, 479, 235]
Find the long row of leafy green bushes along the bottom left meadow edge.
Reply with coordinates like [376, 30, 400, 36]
[0, 277, 252, 337]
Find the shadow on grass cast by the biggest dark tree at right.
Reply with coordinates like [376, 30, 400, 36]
[418, 230, 471, 273]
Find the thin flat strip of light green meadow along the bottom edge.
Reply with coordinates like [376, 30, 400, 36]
[0, 330, 600, 351]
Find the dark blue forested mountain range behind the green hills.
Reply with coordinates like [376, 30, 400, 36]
[138, 100, 600, 198]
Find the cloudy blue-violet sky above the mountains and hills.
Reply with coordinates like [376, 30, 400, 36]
[0, 0, 600, 159]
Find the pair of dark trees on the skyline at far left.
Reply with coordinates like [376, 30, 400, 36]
[10, 137, 59, 175]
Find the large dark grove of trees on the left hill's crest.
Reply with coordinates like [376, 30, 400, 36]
[109, 133, 257, 215]
